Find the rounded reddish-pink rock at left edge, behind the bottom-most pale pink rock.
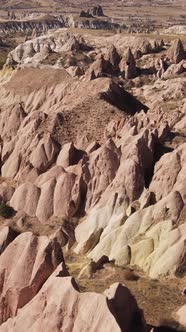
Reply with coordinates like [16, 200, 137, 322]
[0, 232, 63, 323]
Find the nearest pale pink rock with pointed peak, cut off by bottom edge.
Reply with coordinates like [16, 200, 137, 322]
[0, 267, 146, 332]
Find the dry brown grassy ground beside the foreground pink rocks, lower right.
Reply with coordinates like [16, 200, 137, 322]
[65, 252, 185, 327]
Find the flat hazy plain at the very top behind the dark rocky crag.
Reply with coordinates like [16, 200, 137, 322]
[0, 0, 186, 28]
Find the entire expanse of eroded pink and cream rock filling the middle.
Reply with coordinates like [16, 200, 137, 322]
[0, 31, 186, 277]
